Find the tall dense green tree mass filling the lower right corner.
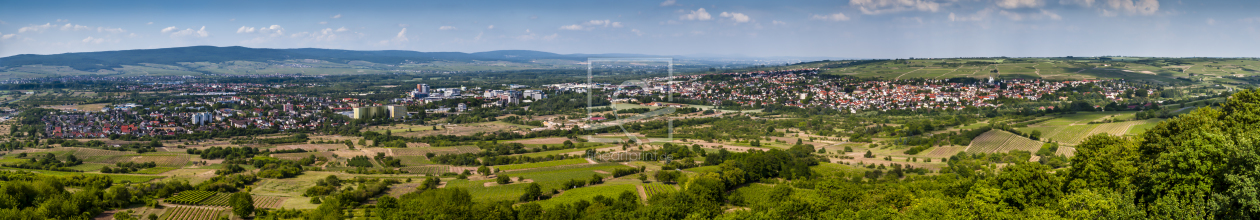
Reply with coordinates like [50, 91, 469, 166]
[1134, 89, 1260, 219]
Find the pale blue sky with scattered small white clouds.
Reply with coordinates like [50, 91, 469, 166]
[0, 0, 1260, 58]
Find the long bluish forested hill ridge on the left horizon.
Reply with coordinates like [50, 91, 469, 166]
[0, 47, 645, 72]
